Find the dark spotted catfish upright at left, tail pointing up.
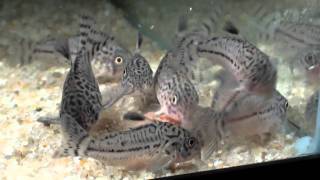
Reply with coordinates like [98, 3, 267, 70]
[58, 15, 102, 156]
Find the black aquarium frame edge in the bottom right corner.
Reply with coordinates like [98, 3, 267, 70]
[157, 154, 320, 180]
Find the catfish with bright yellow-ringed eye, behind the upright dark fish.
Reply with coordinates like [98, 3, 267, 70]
[33, 17, 132, 83]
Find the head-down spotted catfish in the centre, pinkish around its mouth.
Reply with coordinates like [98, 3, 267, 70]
[145, 16, 210, 124]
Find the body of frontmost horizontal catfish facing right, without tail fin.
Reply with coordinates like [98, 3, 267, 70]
[84, 122, 200, 170]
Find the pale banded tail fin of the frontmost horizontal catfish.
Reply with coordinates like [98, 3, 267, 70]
[53, 115, 91, 158]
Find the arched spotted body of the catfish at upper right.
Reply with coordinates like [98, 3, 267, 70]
[197, 36, 277, 97]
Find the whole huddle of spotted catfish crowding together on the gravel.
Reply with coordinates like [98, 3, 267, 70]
[28, 10, 320, 172]
